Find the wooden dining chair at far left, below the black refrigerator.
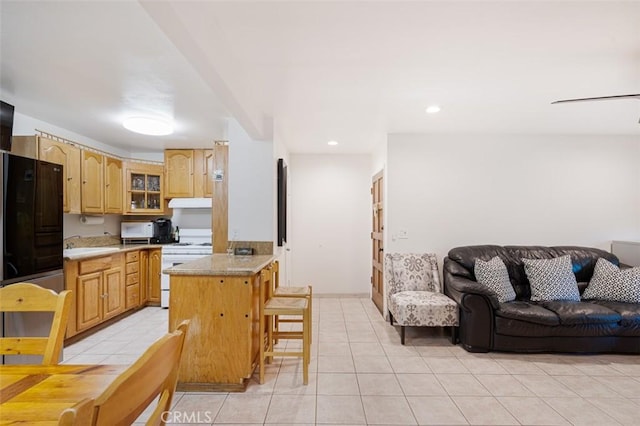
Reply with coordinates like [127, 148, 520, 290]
[0, 283, 71, 365]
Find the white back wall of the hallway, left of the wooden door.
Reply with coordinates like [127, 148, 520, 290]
[288, 154, 372, 294]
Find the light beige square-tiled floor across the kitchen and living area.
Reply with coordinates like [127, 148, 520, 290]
[64, 298, 640, 426]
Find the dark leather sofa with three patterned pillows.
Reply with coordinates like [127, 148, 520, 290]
[443, 245, 640, 353]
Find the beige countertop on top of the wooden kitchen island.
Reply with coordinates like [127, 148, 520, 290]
[162, 254, 275, 276]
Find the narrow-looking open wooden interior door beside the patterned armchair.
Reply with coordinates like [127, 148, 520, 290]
[371, 171, 384, 314]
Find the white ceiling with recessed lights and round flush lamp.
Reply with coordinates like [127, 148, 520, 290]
[0, 0, 640, 153]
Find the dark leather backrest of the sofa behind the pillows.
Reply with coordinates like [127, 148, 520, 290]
[448, 245, 620, 300]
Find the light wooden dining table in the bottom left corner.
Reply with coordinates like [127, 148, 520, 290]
[0, 365, 128, 425]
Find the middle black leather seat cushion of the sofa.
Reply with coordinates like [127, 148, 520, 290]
[541, 301, 622, 325]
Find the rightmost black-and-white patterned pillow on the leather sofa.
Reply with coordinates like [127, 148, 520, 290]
[582, 257, 640, 303]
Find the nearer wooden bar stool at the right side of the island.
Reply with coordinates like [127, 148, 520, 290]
[258, 268, 311, 385]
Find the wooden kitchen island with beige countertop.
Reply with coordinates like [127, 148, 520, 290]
[163, 254, 275, 391]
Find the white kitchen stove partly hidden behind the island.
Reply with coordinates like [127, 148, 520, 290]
[160, 228, 213, 308]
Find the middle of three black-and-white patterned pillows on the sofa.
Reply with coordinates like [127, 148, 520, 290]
[522, 254, 580, 302]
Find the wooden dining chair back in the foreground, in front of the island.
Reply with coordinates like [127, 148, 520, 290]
[92, 320, 190, 426]
